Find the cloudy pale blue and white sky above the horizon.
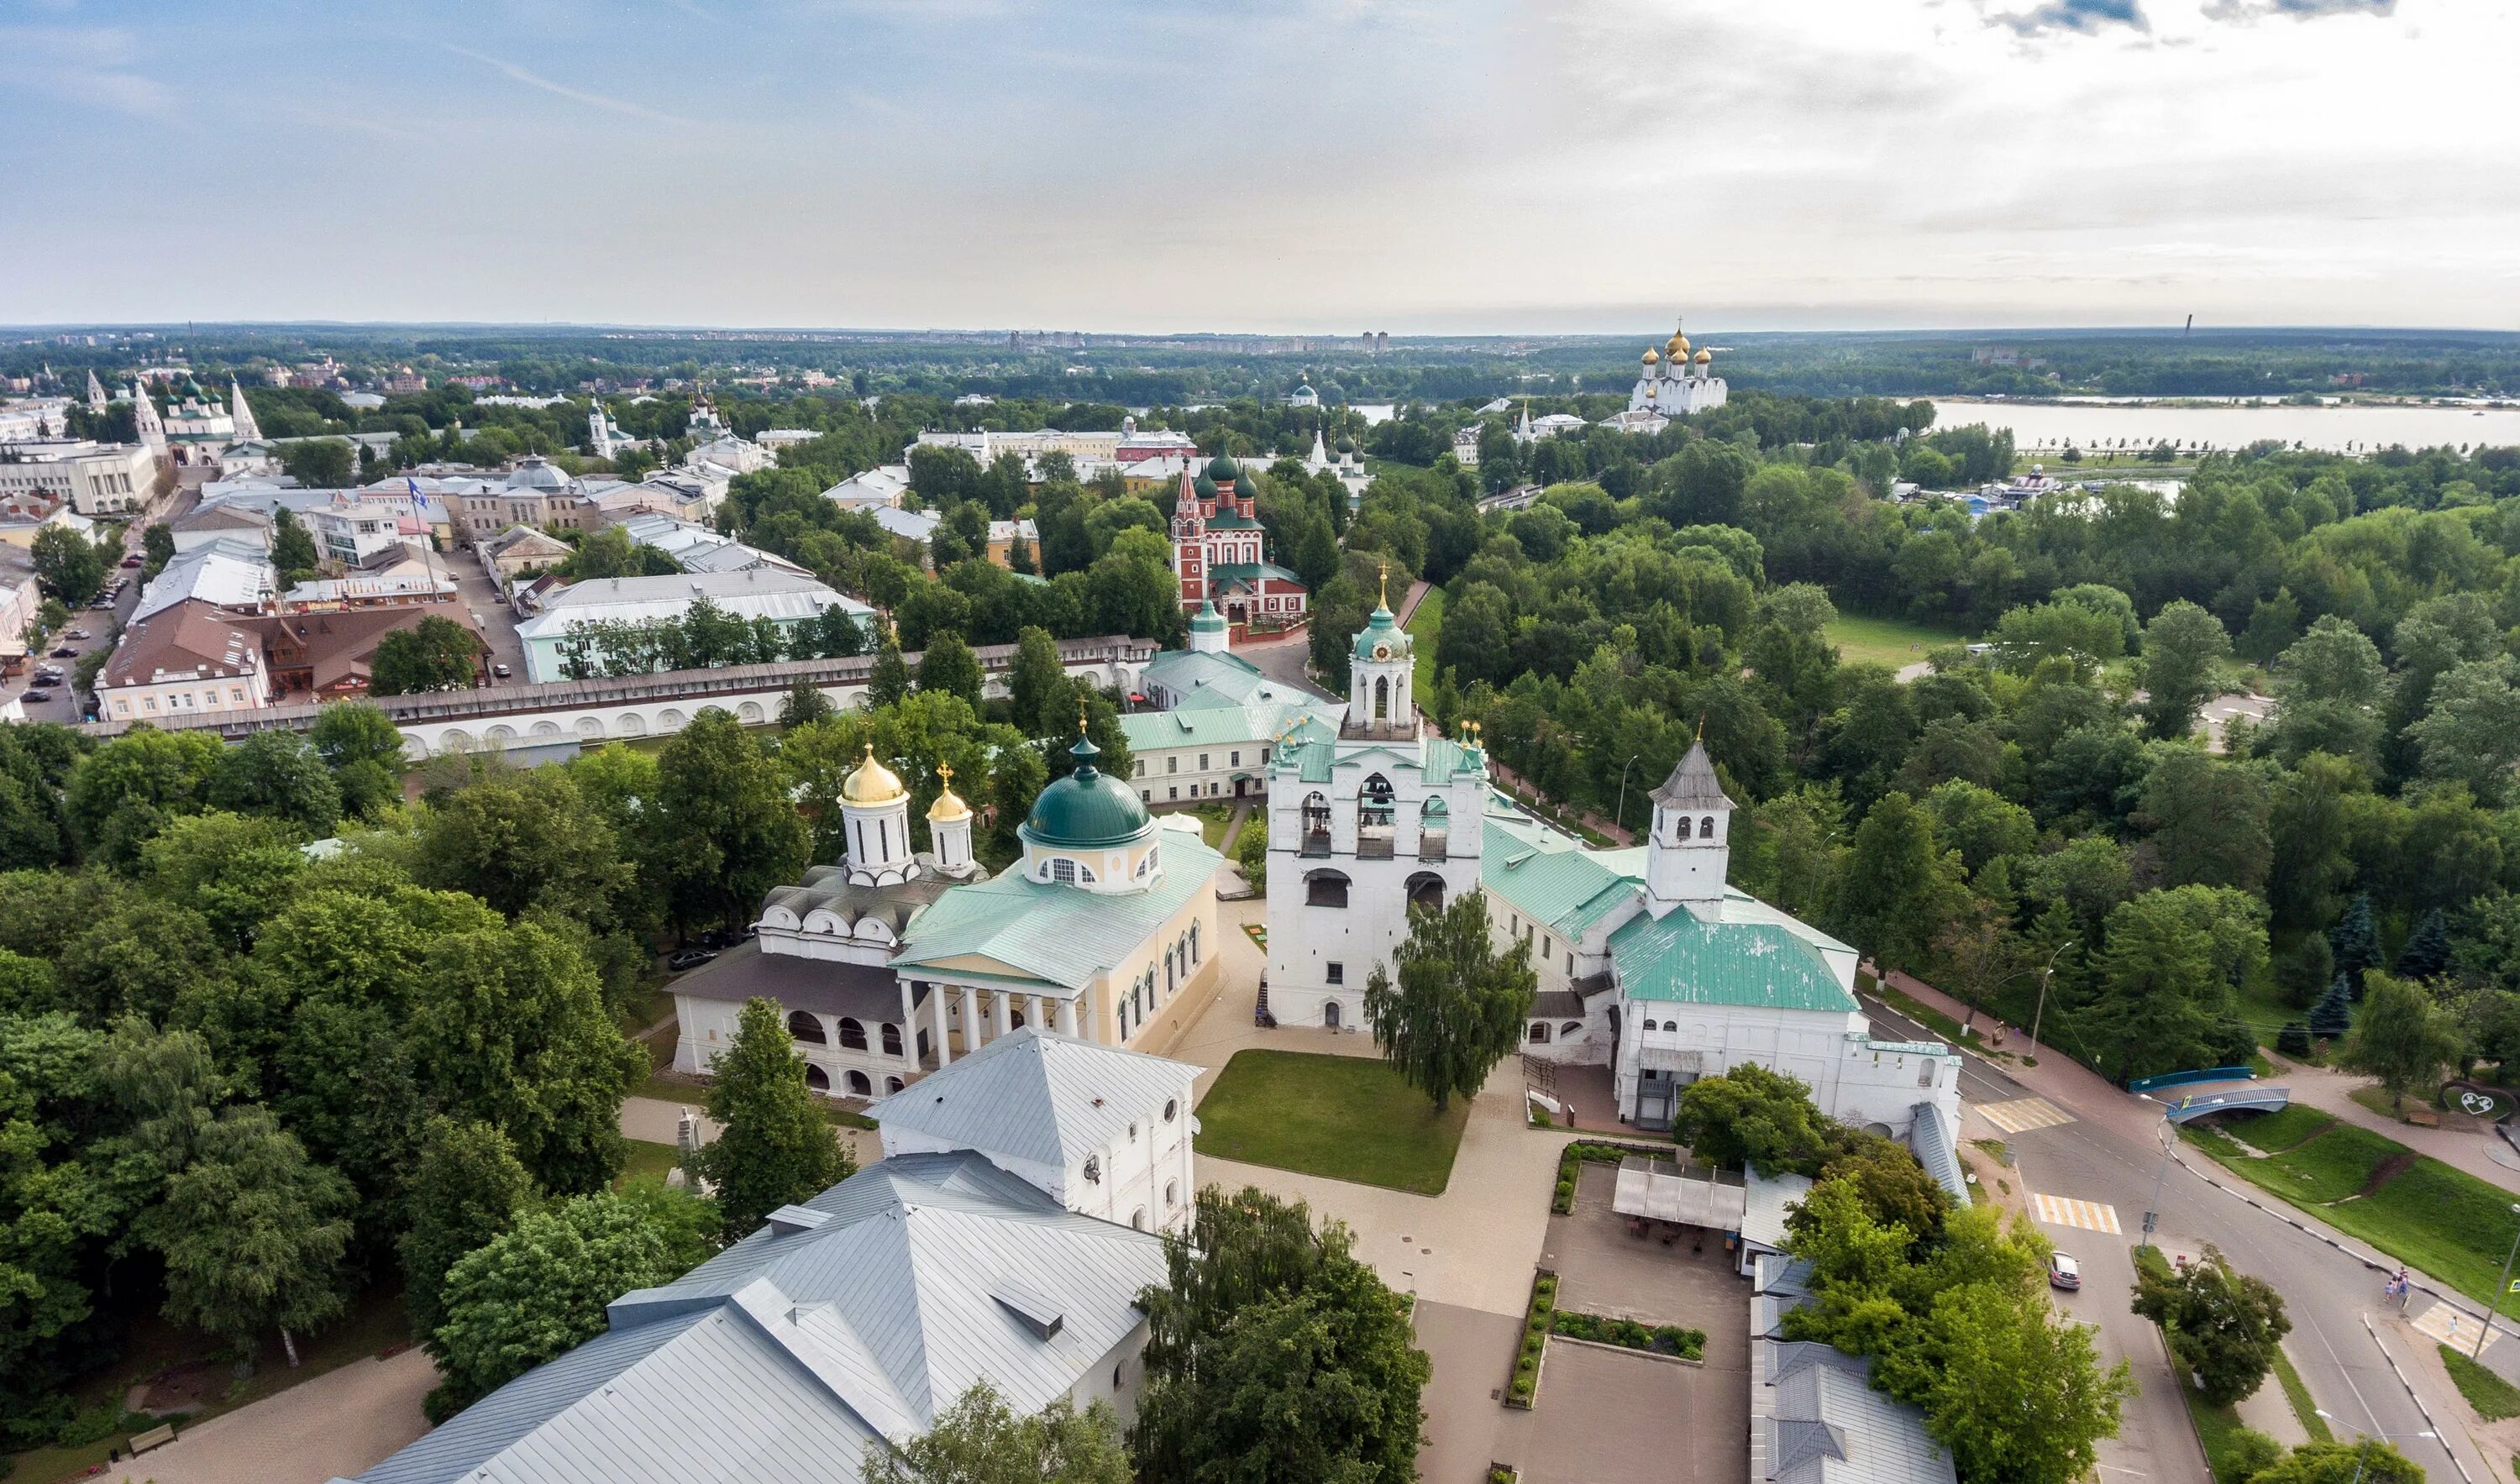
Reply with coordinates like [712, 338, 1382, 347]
[0, 0, 2520, 335]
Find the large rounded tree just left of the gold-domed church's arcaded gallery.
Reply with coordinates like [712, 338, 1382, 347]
[411, 922, 648, 1194]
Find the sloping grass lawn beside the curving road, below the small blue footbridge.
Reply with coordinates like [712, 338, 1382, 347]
[2185, 1109, 2512, 1303]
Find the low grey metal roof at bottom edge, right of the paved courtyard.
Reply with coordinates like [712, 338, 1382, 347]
[1759, 1340, 1958, 1484]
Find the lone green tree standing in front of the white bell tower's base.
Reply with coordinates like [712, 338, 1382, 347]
[1366, 892, 1540, 1114]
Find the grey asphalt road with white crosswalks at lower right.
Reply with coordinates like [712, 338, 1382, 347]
[1865, 998, 2460, 1479]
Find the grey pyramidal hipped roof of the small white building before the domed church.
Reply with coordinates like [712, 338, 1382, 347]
[867, 1025, 1200, 1167]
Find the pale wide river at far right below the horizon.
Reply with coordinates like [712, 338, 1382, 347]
[1933, 401, 2520, 454]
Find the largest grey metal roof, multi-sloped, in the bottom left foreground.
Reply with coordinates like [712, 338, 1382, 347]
[360, 1151, 1164, 1484]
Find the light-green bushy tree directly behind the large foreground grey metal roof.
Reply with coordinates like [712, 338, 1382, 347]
[428, 1184, 718, 1421]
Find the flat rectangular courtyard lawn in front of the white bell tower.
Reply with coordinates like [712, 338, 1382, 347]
[1197, 1051, 1469, 1194]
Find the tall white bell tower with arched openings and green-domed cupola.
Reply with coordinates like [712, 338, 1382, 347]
[1268, 582, 1487, 1030]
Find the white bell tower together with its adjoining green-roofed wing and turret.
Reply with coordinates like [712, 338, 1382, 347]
[1265, 607, 1961, 1154]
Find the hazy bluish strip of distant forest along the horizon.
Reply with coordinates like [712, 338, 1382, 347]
[0, 325, 2520, 406]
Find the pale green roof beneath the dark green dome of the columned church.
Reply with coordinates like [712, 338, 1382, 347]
[892, 831, 1222, 990]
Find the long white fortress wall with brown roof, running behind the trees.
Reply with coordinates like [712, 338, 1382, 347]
[83, 635, 1157, 761]
